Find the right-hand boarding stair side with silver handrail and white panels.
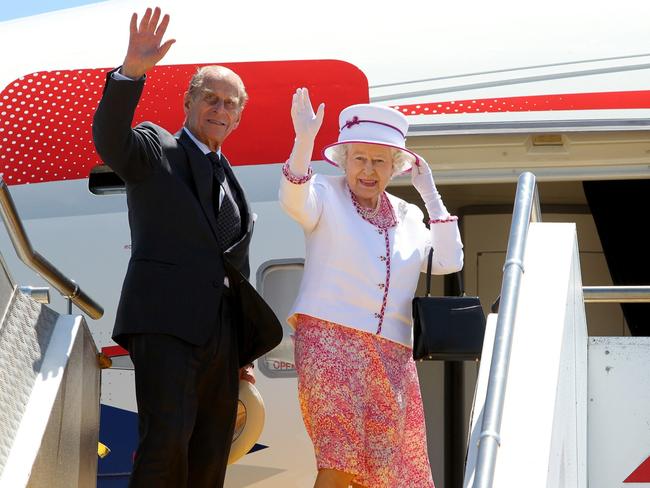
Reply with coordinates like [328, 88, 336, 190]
[458, 173, 650, 488]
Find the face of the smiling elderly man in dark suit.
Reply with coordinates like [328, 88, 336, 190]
[184, 73, 242, 151]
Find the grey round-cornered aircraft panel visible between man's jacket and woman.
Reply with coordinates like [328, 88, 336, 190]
[257, 259, 304, 378]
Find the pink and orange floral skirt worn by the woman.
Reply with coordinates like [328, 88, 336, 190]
[295, 315, 433, 488]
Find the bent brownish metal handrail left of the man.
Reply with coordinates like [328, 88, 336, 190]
[0, 176, 104, 319]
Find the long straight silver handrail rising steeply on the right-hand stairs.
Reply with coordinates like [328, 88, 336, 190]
[474, 172, 542, 488]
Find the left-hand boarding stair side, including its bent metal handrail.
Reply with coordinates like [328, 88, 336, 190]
[0, 178, 103, 488]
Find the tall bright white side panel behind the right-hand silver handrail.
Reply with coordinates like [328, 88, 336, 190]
[465, 223, 587, 488]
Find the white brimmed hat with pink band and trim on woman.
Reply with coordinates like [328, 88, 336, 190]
[323, 103, 420, 173]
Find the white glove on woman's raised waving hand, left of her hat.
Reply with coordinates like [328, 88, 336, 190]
[289, 88, 325, 176]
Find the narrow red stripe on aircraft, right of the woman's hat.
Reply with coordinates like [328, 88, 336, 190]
[394, 90, 650, 115]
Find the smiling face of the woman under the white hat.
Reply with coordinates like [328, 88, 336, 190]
[345, 143, 393, 207]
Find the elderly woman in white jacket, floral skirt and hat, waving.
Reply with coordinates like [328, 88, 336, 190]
[280, 88, 463, 488]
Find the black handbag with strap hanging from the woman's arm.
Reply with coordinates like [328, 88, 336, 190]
[413, 249, 485, 361]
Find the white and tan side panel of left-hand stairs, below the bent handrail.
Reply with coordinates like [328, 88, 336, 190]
[0, 315, 99, 488]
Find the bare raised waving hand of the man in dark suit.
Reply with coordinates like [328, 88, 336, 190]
[121, 7, 176, 80]
